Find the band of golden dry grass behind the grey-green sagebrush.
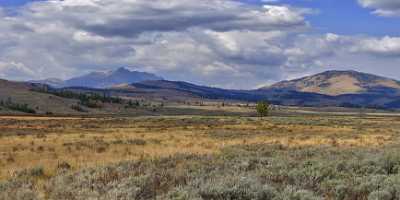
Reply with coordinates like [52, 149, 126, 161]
[0, 116, 400, 179]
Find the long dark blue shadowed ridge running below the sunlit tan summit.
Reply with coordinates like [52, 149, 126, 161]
[97, 76, 400, 109]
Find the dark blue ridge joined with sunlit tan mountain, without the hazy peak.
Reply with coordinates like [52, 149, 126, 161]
[85, 71, 400, 109]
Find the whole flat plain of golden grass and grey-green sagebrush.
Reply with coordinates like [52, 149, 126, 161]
[0, 115, 400, 200]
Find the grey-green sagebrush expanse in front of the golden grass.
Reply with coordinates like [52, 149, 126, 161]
[0, 139, 400, 200]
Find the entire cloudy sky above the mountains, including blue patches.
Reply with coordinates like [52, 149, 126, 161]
[0, 0, 400, 89]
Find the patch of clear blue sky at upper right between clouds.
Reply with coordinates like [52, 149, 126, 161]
[242, 0, 400, 36]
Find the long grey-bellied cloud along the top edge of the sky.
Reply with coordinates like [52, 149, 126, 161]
[48, 0, 305, 37]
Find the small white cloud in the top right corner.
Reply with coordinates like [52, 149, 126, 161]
[358, 0, 400, 17]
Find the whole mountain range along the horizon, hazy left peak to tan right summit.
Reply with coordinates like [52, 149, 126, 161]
[0, 68, 400, 113]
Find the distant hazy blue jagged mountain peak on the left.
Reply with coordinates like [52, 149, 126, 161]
[31, 67, 163, 88]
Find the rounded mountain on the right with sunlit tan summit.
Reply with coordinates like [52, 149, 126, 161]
[262, 71, 400, 96]
